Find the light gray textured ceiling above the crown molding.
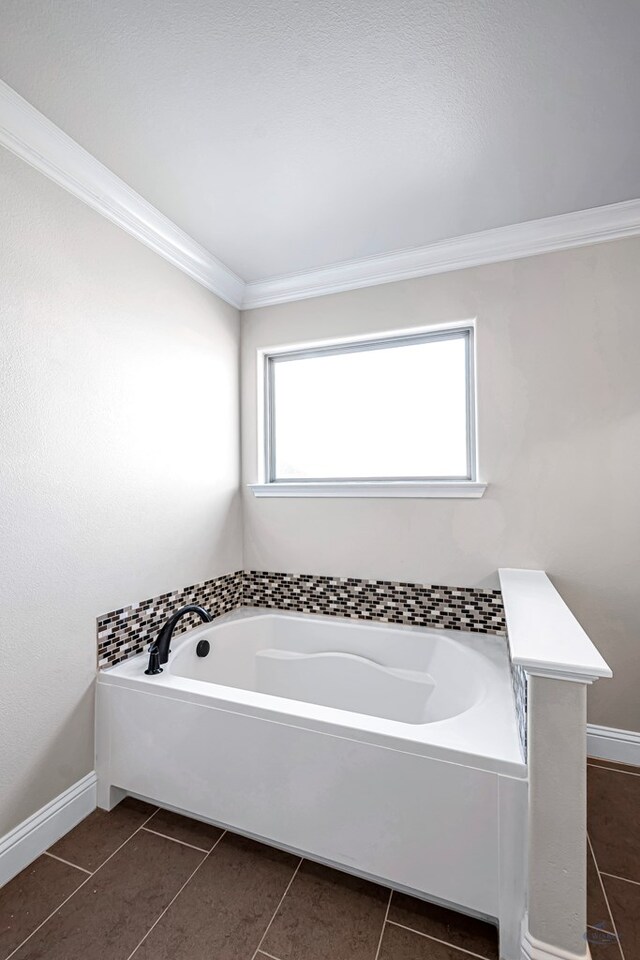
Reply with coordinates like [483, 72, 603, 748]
[0, 0, 640, 280]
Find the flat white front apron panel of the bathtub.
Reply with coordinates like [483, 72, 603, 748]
[98, 684, 499, 917]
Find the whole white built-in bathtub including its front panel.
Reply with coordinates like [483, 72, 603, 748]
[97, 610, 526, 957]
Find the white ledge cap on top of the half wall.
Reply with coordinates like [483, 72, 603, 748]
[498, 569, 613, 683]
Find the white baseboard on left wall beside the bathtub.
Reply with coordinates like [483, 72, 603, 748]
[0, 771, 96, 887]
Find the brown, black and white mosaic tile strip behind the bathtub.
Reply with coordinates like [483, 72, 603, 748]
[98, 570, 506, 667]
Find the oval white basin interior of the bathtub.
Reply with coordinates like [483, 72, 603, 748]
[168, 614, 487, 724]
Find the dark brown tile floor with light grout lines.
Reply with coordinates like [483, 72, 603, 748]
[0, 761, 640, 960]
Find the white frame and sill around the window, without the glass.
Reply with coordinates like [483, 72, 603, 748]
[249, 320, 487, 499]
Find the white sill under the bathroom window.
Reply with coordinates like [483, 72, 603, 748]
[249, 480, 487, 500]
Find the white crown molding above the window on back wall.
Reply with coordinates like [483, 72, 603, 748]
[242, 200, 640, 310]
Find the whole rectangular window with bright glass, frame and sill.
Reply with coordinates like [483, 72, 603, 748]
[253, 325, 484, 496]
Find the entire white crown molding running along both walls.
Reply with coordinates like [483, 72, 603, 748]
[0, 80, 640, 310]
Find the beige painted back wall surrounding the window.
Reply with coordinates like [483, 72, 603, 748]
[242, 239, 640, 730]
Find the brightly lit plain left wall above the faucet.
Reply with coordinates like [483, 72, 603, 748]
[0, 151, 242, 836]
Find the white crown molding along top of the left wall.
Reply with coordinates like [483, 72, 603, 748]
[0, 81, 245, 307]
